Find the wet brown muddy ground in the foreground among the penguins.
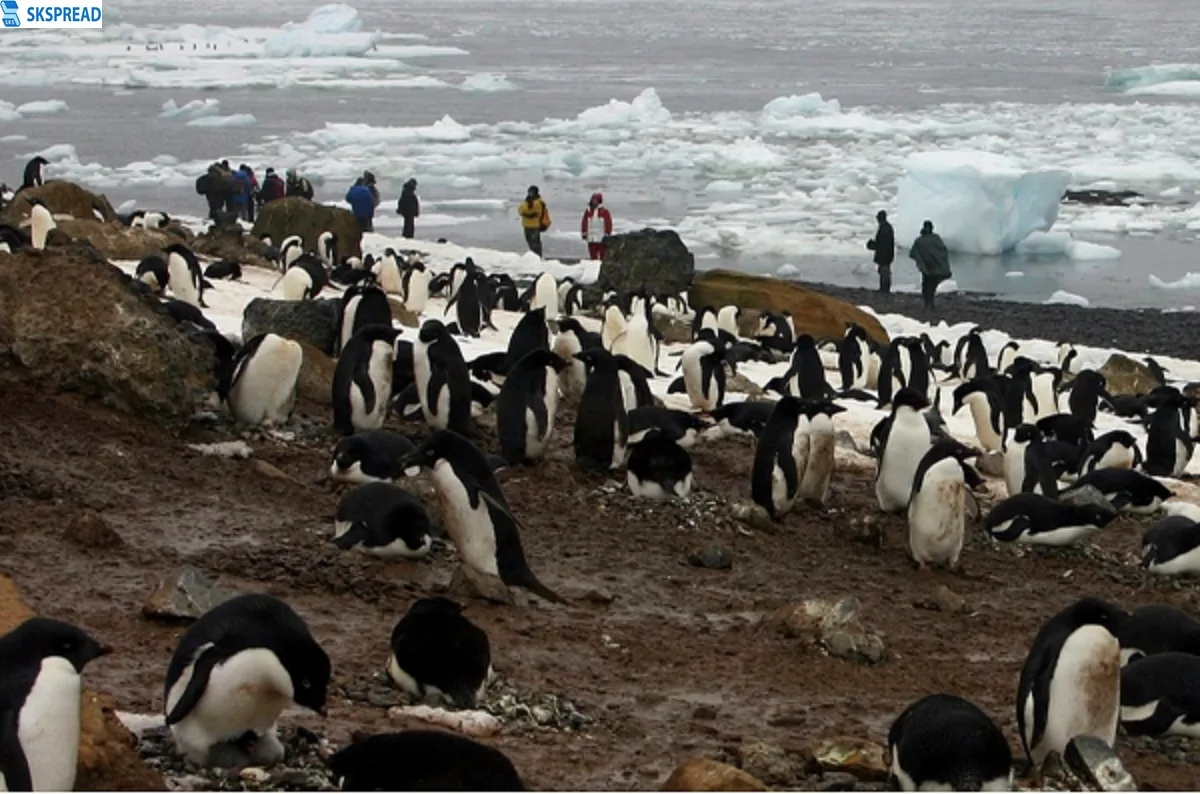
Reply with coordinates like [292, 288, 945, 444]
[0, 389, 1200, 789]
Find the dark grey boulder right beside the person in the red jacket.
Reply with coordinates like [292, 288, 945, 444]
[596, 229, 696, 295]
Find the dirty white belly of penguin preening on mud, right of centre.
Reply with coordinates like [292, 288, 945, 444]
[908, 458, 966, 567]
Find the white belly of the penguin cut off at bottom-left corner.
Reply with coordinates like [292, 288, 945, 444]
[17, 656, 82, 792]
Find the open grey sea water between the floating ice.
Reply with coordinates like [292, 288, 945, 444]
[0, 0, 1200, 308]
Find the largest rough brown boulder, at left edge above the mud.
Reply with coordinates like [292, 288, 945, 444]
[0, 249, 216, 428]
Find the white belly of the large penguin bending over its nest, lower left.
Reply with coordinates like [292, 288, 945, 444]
[167, 648, 294, 764]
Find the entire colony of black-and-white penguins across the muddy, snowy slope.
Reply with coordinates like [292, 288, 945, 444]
[11, 215, 1200, 790]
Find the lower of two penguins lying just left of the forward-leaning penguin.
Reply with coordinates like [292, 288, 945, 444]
[334, 482, 433, 560]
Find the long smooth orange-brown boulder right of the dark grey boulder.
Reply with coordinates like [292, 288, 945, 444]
[688, 270, 888, 344]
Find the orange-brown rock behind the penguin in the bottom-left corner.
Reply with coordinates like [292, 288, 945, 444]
[0, 575, 166, 792]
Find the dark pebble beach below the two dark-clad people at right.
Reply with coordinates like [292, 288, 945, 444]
[797, 282, 1200, 360]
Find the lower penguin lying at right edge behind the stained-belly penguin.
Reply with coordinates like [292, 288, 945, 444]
[1121, 652, 1200, 739]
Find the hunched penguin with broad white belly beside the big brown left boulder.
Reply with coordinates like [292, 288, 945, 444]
[229, 333, 304, 427]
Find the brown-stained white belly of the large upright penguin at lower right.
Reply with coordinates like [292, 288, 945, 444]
[1025, 624, 1121, 764]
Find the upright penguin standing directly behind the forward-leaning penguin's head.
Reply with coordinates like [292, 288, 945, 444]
[413, 320, 472, 434]
